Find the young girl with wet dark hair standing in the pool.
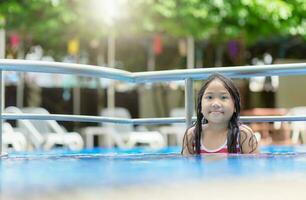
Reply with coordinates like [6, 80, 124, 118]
[182, 74, 258, 155]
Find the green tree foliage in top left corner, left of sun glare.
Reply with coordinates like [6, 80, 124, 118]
[0, 0, 77, 56]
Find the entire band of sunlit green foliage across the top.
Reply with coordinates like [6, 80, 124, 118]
[0, 0, 306, 59]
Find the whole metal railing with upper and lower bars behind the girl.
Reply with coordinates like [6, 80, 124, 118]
[0, 59, 306, 154]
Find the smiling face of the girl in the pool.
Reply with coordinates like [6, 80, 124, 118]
[201, 79, 235, 123]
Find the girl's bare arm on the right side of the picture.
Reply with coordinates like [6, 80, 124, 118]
[239, 125, 259, 153]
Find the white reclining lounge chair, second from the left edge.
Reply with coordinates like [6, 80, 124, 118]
[5, 107, 84, 150]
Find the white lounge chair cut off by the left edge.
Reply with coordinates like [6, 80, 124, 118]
[2, 122, 27, 151]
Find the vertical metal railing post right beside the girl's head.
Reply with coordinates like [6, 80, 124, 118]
[185, 78, 194, 128]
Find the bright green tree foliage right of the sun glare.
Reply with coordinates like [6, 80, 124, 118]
[152, 0, 306, 42]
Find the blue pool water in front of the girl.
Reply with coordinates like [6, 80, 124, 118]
[0, 146, 306, 193]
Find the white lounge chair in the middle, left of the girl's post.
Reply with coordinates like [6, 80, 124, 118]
[101, 107, 165, 148]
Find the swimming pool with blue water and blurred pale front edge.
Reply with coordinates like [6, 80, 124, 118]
[0, 146, 306, 199]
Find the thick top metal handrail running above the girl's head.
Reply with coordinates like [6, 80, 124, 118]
[0, 59, 306, 83]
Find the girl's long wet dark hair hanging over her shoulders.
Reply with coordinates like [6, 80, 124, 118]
[182, 73, 241, 154]
